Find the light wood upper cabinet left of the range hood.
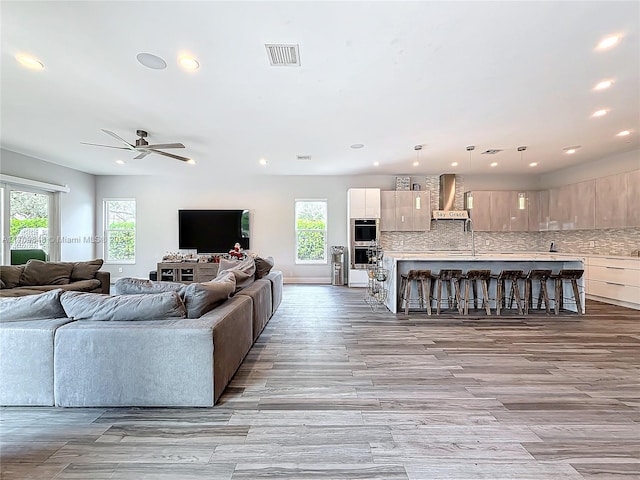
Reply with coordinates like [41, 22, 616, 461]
[380, 190, 431, 232]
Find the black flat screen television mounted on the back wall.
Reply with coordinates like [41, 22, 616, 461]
[178, 210, 249, 253]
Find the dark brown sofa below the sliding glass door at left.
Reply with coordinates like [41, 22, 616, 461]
[0, 259, 110, 297]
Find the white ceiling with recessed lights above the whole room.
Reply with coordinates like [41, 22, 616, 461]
[0, 0, 640, 176]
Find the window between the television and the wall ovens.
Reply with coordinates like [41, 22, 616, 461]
[296, 200, 327, 263]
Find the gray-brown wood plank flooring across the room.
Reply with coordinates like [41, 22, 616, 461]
[0, 285, 640, 480]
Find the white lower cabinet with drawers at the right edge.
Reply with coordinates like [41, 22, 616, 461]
[585, 257, 640, 310]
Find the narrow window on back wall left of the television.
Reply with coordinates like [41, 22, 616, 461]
[104, 199, 136, 263]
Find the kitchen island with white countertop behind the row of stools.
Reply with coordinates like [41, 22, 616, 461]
[382, 251, 585, 313]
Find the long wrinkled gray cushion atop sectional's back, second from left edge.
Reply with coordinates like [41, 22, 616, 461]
[60, 292, 186, 321]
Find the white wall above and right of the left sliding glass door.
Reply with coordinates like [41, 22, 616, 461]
[0, 149, 96, 262]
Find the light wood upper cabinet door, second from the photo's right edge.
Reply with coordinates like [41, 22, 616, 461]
[596, 173, 628, 228]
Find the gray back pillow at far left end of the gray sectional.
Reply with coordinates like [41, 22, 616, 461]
[0, 288, 67, 323]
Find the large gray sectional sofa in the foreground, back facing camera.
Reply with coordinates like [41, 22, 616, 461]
[0, 256, 283, 407]
